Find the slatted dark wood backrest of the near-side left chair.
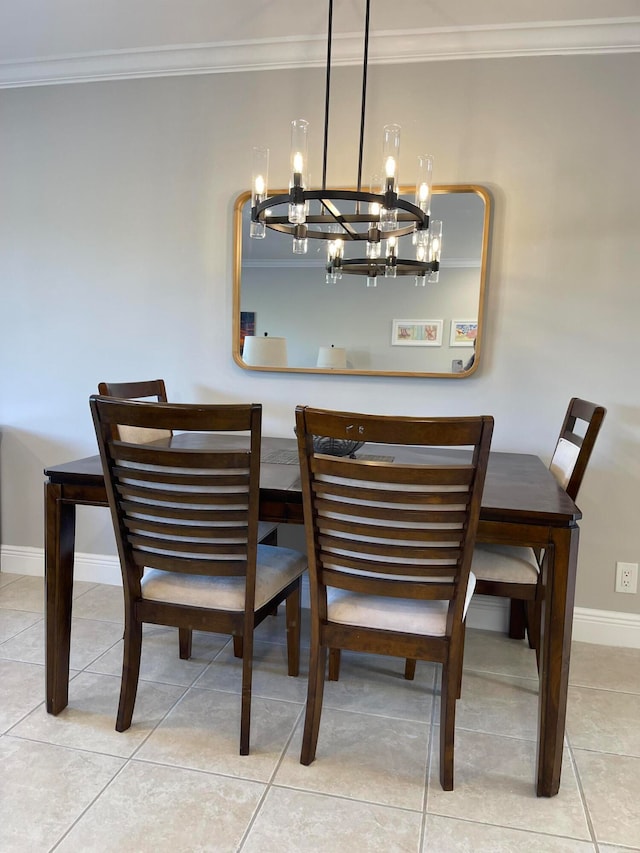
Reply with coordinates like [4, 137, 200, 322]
[90, 395, 262, 607]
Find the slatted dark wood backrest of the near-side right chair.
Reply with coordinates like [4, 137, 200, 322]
[296, 407, 493, 633]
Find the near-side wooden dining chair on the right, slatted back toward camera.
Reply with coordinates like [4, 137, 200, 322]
[296, 406, 493, 790]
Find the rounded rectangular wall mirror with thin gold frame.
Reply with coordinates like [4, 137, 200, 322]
[233, 185, 491, 378]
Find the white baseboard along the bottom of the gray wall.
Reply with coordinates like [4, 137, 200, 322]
[0, 545, 640, 649]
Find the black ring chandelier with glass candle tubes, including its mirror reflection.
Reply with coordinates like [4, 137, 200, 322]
[249, 0, 442, 287]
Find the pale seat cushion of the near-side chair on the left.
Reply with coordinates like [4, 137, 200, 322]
[141, 545, 307, 611]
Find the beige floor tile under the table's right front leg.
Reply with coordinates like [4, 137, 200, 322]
[427, 727, 589, 840]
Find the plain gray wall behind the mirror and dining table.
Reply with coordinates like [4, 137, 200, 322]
[0, 54, 640, 613]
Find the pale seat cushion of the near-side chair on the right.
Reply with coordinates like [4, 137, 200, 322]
[327, 572, 476, 637]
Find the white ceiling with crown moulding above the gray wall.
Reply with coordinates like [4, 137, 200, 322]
[0, 0, 640, 87]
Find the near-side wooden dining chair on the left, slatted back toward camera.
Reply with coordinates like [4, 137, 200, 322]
[90, 395, 307, 755]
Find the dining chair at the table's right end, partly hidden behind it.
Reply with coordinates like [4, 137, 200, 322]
[472, 397, 606, 656]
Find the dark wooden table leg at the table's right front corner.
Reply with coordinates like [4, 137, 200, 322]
[536, 526, 580, 797]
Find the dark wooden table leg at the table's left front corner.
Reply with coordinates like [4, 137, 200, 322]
[44, 483, 76, 714]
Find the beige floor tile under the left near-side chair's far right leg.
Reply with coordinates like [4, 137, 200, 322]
[197, 639, 308, 704]
